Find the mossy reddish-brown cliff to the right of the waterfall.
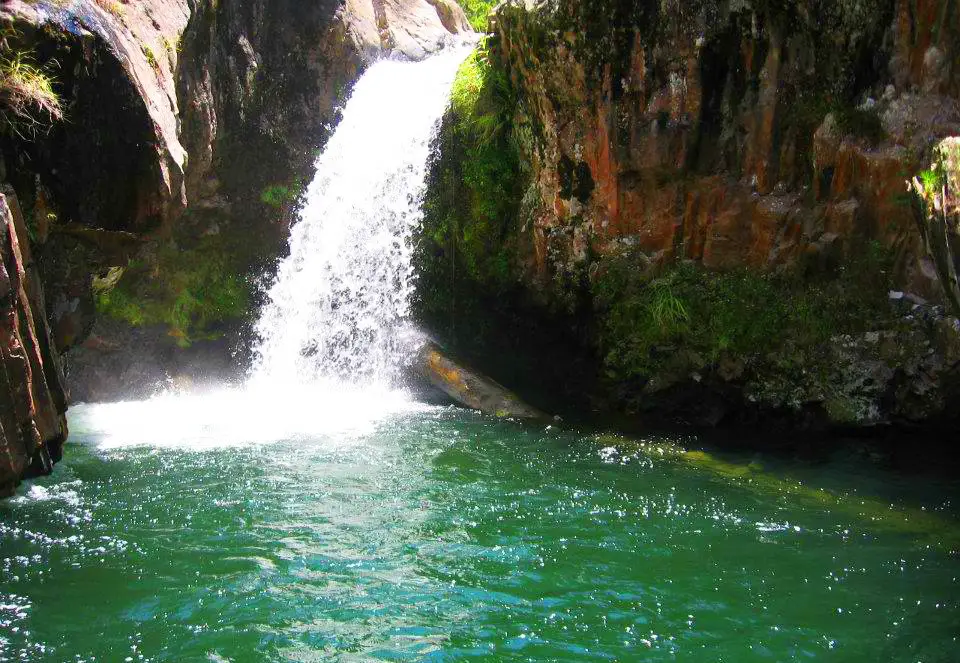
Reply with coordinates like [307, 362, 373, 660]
[421, 0, 960, 434]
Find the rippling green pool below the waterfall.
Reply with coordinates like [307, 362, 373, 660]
[0, 396, 960, 663]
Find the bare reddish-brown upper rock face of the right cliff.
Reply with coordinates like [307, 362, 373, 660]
[496, 0, 960, 304]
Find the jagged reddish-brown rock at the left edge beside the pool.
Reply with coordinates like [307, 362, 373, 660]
[0, 194, 67, 496]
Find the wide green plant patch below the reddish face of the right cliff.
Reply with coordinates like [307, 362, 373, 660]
[592, 244, 892, 379]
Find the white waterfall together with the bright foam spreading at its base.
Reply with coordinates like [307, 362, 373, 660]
[71, 47, 470, 450]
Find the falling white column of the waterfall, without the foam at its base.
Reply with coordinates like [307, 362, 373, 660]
[251, 47, 469, 384]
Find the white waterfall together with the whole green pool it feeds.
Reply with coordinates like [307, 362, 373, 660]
[0, 42, 960, 663]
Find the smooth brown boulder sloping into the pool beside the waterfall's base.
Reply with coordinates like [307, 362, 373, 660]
[415, 343, 546, 419]
